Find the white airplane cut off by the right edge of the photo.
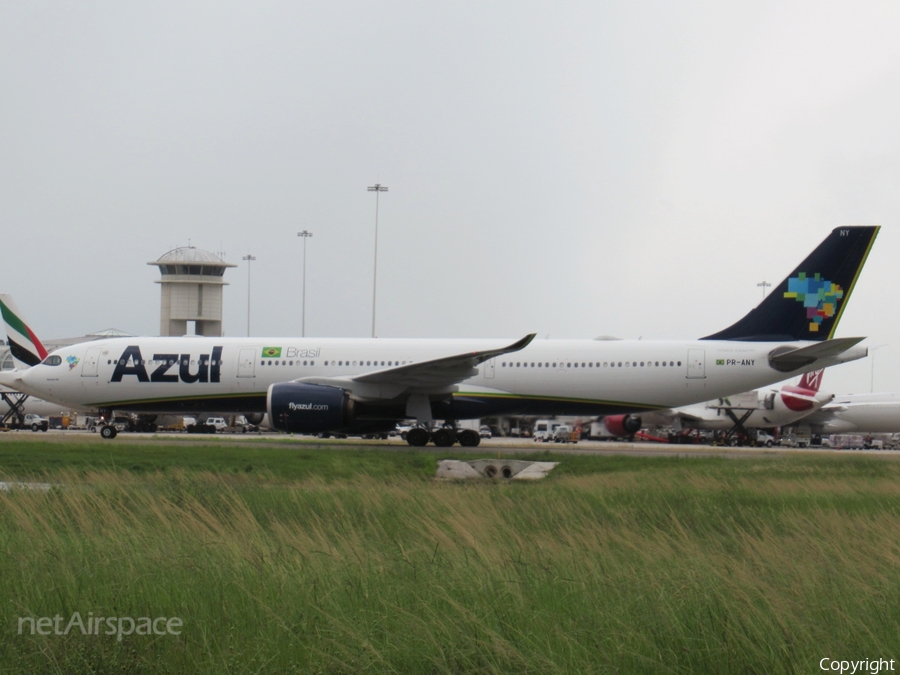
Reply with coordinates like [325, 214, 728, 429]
[802, 393, 900, 436]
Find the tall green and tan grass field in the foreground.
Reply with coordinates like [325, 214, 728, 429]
[0, 438, 900, 673]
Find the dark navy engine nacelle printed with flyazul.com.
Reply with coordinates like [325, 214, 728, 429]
[266, 382, 354, 434]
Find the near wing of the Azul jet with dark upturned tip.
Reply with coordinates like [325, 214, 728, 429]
[294, 333, 536, 399]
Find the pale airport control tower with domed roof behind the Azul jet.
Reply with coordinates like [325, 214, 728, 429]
[147, 246, 237, 337]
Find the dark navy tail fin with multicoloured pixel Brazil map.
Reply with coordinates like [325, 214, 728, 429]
[701, 226, 881, 342]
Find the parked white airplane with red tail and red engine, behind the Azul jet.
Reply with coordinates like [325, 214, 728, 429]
[603, 370, 834, 436]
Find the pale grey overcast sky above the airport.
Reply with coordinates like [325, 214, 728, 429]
[0, 0, 900, 393]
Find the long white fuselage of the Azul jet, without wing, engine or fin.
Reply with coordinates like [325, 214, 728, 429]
[9, 337, 865, 419]
